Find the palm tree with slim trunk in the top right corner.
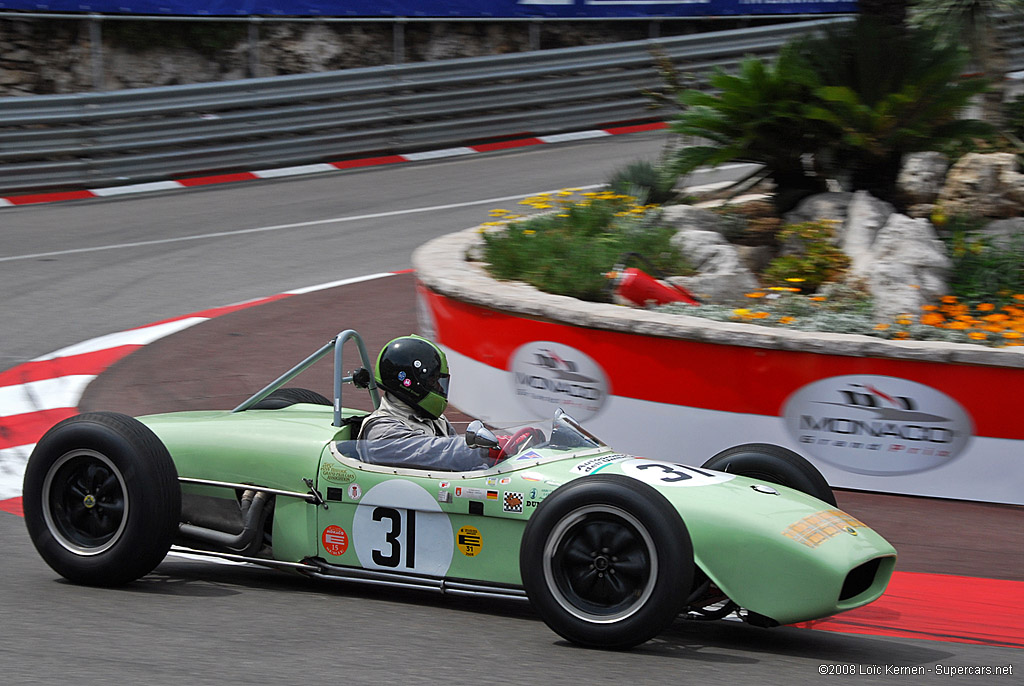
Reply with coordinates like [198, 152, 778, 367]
[910, 0, 1024, 125]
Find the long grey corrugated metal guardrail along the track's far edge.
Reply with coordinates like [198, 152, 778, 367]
[0, 14, 1024, 192]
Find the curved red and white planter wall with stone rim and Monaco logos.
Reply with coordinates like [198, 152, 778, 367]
[413, 229, 1024, 505]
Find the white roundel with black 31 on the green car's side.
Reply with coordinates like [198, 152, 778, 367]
[352, 480, 455, 576]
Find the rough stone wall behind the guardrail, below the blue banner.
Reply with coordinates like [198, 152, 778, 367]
[0, 17, 753, 96]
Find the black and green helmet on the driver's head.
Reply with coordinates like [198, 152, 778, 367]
[374, 335, 449, 419]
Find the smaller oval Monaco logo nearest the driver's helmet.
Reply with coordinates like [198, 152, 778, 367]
[510, 341, 608, 422]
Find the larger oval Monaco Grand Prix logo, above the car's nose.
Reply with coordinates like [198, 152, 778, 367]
[782, 375, 974, 476]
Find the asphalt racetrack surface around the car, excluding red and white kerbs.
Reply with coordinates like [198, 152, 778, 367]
[0, 136, 1024, 684]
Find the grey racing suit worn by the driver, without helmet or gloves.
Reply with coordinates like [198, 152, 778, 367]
[358, 393, 489, 472]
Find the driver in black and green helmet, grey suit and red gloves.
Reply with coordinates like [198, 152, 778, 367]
[358, 336, 536, 472]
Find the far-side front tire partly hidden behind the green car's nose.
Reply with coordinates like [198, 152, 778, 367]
[701, 443, 837, 507]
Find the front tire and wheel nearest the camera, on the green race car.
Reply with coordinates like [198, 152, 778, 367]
[519, 474, 694, 649]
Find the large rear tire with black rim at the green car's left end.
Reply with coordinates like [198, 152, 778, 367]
[23, 413, 181, 587]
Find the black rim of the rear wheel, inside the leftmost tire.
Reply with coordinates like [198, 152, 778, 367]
[43, 449, 128, 555]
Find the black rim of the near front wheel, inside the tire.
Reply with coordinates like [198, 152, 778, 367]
[544, 506, 657, 623]
